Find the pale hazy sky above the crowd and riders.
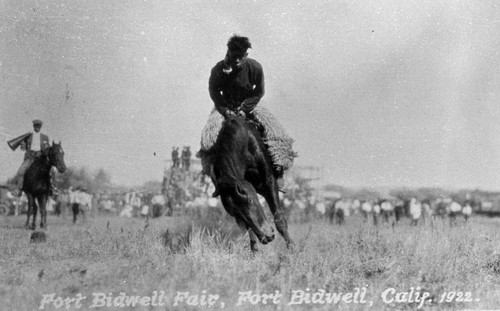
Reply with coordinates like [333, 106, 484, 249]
[0, 0, 500, 191]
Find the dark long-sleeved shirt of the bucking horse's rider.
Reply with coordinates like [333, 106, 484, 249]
[208, 58, 264, 114]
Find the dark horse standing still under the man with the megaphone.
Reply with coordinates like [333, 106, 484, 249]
[23, 142, 66, 230]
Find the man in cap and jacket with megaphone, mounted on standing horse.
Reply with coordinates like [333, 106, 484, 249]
[11, 119, 52, 196]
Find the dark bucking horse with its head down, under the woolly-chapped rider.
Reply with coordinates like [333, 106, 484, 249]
[199, 116, 293, 252]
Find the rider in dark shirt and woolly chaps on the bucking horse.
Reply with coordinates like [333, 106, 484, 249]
[198, 35, 296, 190]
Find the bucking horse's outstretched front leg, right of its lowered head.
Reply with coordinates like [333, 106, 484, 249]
[261, 178, 294, 248]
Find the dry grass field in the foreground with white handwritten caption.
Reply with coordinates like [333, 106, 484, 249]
[0, 213, 500, 310]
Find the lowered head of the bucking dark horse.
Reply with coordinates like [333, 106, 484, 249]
[219, 180, 274, 244]
